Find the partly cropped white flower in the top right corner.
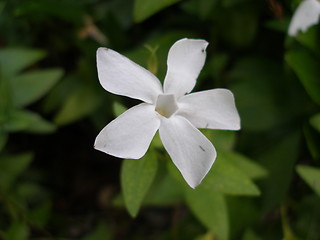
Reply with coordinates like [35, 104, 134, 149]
[288, 0, 320, 36]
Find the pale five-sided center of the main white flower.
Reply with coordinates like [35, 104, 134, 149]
[155, 94, 178, 118]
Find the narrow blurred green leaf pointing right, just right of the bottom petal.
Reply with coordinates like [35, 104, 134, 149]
[223, 152, 268, 179]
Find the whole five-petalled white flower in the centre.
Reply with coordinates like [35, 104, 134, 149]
[95, 39, 240, 188]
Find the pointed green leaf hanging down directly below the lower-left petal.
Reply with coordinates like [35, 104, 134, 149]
[121, 151, 158, 217]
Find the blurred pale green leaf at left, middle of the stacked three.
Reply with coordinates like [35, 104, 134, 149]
[10, 69, 63, 107]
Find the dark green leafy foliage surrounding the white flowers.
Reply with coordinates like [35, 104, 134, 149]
[0, 0, 320, 240]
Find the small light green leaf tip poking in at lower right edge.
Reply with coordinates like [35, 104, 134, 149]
[296, 165, 320, 196]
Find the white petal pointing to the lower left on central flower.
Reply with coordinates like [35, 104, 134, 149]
[94, 103, 160, 159]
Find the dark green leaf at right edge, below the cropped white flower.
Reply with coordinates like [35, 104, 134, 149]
[285, 51, 320, 104]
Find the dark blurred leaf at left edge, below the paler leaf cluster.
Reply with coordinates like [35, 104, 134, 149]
[0, 153, 33, 189]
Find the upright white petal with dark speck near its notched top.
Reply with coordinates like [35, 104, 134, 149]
[164, 38, 208, 97]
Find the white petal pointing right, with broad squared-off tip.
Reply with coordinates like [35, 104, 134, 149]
[176, 89, 240, 130]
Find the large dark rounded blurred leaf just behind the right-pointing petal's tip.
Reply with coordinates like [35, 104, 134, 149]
[231, 57, 299, 131]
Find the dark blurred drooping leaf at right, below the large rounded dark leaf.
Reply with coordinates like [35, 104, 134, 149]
[257, 132, 300, 212]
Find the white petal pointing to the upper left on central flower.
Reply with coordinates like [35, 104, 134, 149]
[97, 48, 162, 103]
